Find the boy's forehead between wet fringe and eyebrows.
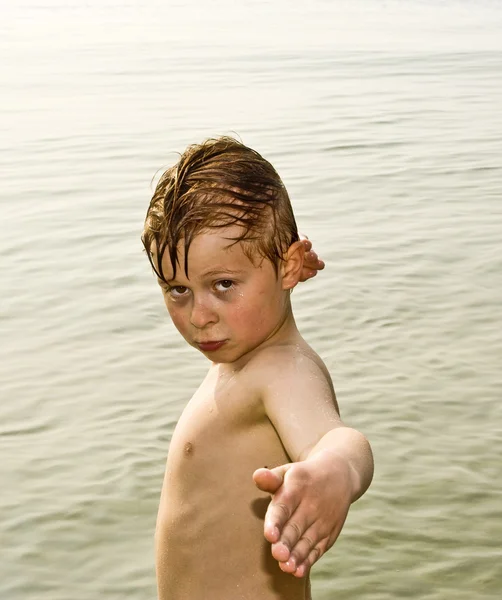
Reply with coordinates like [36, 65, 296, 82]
[162, 227, 261, 281]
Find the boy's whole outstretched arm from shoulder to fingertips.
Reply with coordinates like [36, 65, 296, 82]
[254, 352, 373, 577]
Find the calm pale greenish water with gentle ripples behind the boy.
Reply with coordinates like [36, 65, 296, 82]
[0, 0, 502, 600]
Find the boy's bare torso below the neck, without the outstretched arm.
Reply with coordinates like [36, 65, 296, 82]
[156, 365, 308, 600]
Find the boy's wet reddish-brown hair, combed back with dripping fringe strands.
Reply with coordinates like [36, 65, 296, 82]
[141, 137, 299, 281]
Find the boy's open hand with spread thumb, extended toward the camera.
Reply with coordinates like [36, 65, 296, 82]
[253, 453, 352, 577]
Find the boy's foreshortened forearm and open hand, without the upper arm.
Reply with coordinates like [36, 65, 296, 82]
[253, 427, 373, 577]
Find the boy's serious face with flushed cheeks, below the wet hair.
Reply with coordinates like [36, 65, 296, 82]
[159, 227, 292, 363]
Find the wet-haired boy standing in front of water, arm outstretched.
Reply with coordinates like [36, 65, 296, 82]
[142, 138, 373, 600]
